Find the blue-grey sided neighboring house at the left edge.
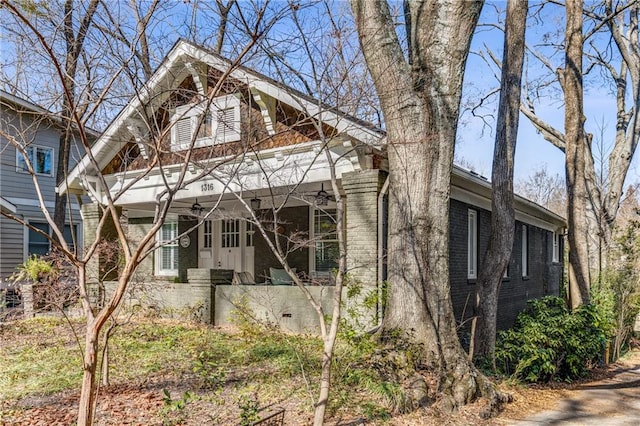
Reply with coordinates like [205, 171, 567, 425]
[0, 91, 89, 282]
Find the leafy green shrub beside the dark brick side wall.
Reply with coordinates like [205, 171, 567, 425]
[496, 296, 606, 382]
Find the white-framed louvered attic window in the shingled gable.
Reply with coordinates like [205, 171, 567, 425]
[171, 95, 240, 151]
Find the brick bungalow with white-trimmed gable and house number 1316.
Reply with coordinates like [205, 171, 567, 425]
[60, 41, 565, 330]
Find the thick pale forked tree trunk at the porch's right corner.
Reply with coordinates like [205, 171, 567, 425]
[351, 0, 508, 408]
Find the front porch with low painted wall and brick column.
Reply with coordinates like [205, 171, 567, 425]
[84, 170, 386, 332]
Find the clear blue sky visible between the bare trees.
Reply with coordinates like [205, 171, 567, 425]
[0, 0, 640, 188]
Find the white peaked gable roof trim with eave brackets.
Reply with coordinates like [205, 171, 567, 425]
[58, 40, 384, 192]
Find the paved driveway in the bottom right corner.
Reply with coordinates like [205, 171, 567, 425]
[515, 364, 640, 426]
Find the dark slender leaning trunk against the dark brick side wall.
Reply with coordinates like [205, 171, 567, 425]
[471, 0, 528, 365]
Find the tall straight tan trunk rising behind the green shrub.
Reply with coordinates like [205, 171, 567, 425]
[560, 0, 590, 308]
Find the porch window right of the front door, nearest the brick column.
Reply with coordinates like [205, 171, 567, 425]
[313, 209, 340, 275]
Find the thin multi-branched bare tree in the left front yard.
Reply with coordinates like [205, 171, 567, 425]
[2, 2, 279, 425]
